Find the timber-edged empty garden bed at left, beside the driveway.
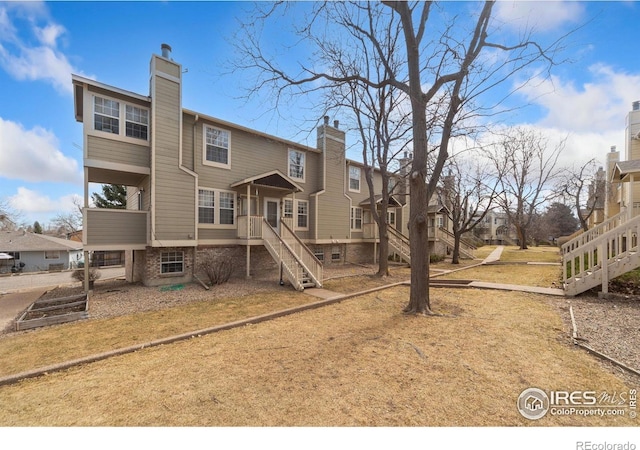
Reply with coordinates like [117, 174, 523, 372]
[16, 294, 89, 331]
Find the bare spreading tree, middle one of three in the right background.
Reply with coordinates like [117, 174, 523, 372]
[488, 127, 566, 250]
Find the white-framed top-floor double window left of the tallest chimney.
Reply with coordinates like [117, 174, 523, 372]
[93, 95, 149, 141]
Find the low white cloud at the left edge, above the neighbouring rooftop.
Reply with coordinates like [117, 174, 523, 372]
[0, 117, 83, 184]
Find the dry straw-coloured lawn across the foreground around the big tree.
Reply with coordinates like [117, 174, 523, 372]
[0, 287, 637, 426]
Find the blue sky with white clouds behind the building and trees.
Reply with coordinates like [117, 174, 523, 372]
[0, 1, 640, 224]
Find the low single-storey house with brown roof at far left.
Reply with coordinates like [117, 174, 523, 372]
[0, 230, 82, 272]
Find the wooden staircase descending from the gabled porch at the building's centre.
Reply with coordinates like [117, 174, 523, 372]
[262, 219, 322, 291]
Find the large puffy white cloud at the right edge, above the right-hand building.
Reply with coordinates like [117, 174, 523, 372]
[520, 64, 640, 133]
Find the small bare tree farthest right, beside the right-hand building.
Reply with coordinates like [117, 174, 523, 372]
[558, 159, 606, 231]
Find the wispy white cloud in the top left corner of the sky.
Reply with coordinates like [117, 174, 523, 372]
[0, 2, 81, 95]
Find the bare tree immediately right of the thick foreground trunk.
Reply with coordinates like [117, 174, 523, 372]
[438, 152, 500, 264]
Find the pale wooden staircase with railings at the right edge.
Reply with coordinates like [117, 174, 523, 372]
[561, 212, 640, 296]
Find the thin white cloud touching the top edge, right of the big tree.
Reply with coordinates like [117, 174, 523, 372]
[494, 1, 585, 31]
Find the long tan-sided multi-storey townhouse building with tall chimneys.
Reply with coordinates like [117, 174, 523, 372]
[72, 45, 420, 289]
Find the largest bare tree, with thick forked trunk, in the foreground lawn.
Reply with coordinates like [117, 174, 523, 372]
[236, 1, 559, 314]
